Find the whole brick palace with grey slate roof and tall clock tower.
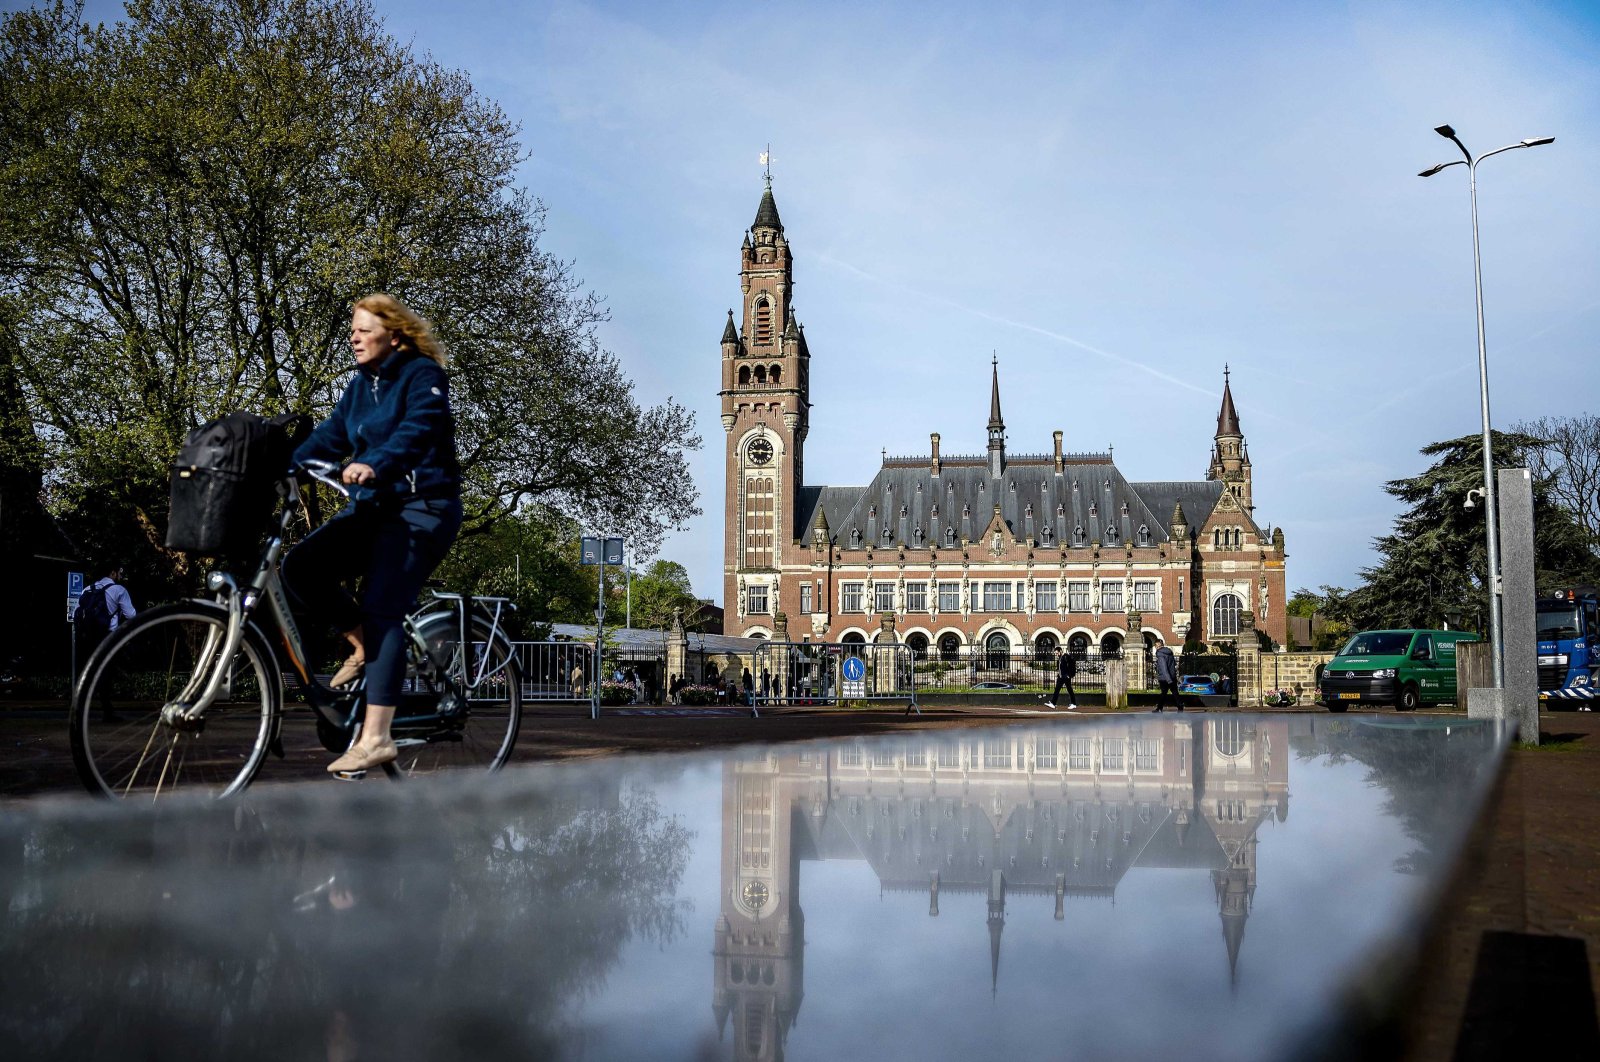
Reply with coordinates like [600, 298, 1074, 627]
[720, 179, 1286, 657]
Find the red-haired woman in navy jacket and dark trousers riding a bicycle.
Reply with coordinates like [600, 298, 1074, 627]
[282, 294, 461, 773]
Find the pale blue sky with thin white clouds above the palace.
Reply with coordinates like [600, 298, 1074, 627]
[65, 0, 1600, 595]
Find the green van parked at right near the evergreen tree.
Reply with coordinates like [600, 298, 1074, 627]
[1317, 630, 1478, 712]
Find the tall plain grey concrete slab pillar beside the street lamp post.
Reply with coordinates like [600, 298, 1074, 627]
[1467, 469, 1539, 745]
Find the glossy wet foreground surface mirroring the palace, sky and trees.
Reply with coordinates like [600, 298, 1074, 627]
[0, 713, 1504, 1060]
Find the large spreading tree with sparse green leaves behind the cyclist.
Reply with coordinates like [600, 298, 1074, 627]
[0, 0, 699, 604]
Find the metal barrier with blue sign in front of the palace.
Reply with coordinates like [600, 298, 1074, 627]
[752, 641, 922, 715]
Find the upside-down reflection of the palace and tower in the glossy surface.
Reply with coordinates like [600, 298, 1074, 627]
[712, 715, 1290, 1060]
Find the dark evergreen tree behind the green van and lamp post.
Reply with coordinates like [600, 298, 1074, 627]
[1322, 432, 1600, 630]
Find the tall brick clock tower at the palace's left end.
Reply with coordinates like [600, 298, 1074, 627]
[720, 174, 811, 630]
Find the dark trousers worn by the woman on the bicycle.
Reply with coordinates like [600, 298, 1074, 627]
[282, 497, 461, 705]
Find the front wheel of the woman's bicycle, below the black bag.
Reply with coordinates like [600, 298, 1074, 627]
[69, 601, 280, 800]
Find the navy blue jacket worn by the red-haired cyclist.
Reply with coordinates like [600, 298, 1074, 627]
[294, 350, 461, 499]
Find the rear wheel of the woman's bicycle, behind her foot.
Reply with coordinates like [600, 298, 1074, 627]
[394, 611, 522, 776]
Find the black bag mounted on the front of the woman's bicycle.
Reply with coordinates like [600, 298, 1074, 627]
[166, 413, 310, 557]
